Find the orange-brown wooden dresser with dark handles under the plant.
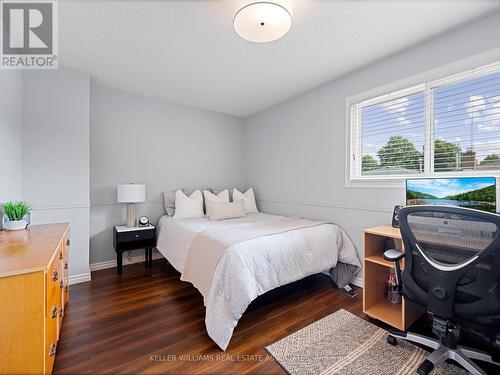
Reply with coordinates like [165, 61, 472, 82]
[0, 224, 70, 374]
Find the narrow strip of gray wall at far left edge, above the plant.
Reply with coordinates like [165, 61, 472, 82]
[0, 70, 22, 209]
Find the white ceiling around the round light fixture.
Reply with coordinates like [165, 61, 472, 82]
[59, 0, 500, 117]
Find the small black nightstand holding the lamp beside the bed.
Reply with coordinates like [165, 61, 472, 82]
[113, 225, 156, 274]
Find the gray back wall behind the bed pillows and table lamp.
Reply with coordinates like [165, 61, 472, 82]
[90, 84, 244, 264]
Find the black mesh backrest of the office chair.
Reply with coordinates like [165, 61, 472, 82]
[399, 206, 500, 319]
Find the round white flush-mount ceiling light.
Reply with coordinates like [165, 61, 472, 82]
[234, 1, 292, 43]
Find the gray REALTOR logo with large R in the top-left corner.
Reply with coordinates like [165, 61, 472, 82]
[0, 0, 58, 69]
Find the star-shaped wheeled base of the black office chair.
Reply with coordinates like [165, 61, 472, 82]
[387, 330, 500, 375]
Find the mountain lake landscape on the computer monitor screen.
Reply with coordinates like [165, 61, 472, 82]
[406, 177, 496, 213]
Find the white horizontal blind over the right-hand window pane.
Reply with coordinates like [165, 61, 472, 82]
[432, 72, 500, 172]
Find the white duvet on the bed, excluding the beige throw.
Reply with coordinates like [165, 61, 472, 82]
[157, 213, 360, 350]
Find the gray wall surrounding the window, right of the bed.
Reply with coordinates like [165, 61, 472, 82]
[245, 14, 500, 280]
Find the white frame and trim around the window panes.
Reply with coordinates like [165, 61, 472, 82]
[345, 49, 500, 188]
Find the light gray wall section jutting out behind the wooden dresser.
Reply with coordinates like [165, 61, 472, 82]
[22, 69, 90, 280]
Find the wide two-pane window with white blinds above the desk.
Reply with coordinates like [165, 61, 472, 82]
[349, 65, 500, 184]
